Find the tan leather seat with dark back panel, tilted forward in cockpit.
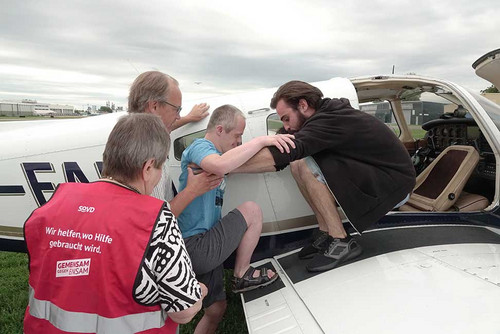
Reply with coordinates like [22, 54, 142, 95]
[399, 145, 489, 211]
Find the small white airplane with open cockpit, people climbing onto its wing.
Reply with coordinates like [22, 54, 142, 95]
[0, 49, 500, 334]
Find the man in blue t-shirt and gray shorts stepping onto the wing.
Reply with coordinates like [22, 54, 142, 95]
[178, 105, 295, 333]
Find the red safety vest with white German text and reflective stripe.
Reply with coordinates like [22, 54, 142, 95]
[24, 182, 177, 334]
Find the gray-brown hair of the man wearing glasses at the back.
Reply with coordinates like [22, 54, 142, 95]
[128, 71, 179, 113]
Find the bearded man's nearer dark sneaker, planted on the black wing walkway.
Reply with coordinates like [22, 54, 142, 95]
[306, 235, 363, 272]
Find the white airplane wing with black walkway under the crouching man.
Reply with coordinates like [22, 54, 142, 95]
[242, 225, 500, 334]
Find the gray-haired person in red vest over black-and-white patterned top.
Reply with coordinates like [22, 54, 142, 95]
[24, 114, 207, 334]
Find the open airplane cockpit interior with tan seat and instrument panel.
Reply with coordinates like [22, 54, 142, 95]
[354, 81, 498, 212]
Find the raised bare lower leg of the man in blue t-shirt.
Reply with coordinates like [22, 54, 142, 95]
[234, 202, 275, 278]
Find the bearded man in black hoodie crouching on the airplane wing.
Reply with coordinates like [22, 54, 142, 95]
[234, 81, 415, 272]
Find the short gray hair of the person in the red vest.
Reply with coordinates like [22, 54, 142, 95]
[102, 113, 170, 182]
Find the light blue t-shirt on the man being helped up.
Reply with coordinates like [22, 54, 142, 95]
[178, 138, 226, 238]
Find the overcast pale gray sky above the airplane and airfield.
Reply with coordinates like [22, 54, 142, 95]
[0, 0, 500, 108]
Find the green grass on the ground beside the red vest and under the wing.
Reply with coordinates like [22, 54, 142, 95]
[0, 252, 248, 334]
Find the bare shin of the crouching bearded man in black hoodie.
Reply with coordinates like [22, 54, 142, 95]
[292, 160, 347, 238]
